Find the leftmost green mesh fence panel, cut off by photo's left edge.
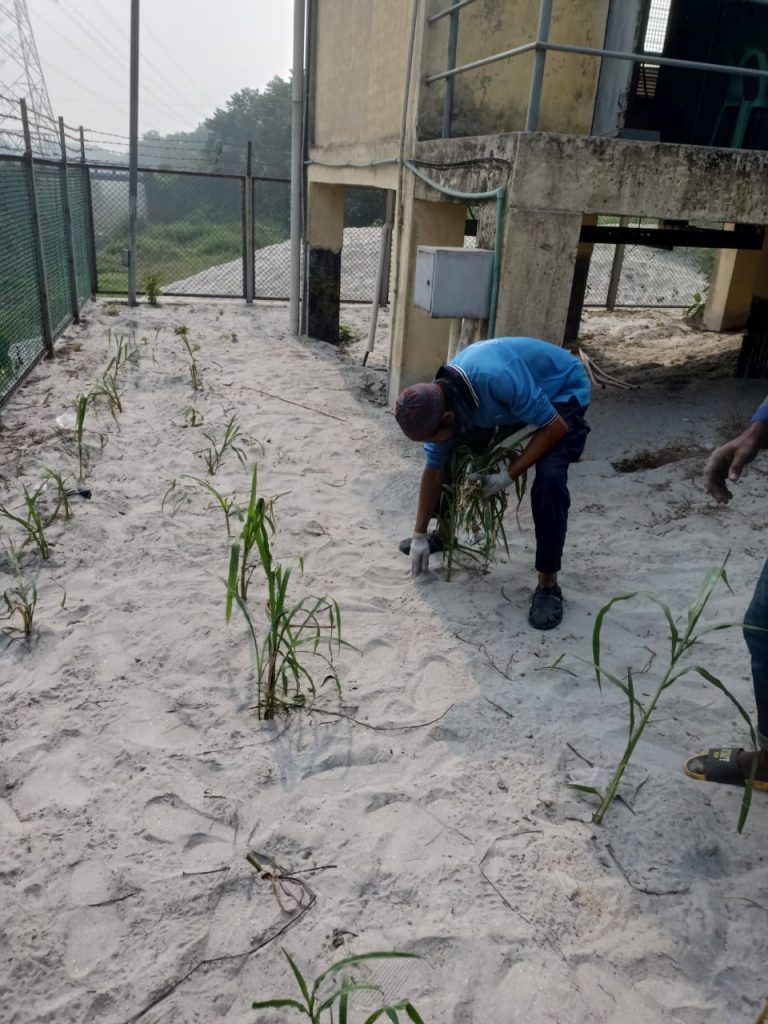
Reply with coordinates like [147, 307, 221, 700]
[0, 161, 45, 404]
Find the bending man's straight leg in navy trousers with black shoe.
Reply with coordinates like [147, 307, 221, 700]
[528, 409, 589, 629]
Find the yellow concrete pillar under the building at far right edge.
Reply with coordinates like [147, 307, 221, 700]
[701, 224, 768, 331]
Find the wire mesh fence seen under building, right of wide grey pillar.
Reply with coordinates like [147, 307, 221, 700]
[585, 243, 714, 307]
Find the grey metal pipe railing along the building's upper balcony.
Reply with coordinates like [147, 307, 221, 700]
[424, 0, 768, 138]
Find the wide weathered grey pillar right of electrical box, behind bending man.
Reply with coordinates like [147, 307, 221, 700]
[496, 208, 582, 345]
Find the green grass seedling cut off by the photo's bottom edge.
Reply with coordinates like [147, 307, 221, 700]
[252, 949, 424, 1024]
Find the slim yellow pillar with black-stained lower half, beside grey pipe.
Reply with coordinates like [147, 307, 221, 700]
[307, 181, 344, 344]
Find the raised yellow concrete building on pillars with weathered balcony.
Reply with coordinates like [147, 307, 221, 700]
[305, 0, 768, 396]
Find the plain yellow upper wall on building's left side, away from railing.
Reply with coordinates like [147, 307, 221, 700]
[313, 0, 411, 147]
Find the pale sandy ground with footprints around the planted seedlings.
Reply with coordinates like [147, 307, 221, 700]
[0, 300, 768, 1024]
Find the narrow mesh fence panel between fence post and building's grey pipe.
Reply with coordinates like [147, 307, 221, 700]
[253, 178, 291, 299]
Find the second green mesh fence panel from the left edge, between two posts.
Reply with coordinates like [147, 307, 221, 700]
[35, 164, 72, 335]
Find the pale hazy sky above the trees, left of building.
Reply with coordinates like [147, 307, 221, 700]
[27, 0, 293, 141]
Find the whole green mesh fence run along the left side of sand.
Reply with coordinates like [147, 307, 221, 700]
[0, 156, 92, 404]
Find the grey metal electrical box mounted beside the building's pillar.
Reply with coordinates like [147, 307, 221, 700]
[414, 246, 494, 319]
